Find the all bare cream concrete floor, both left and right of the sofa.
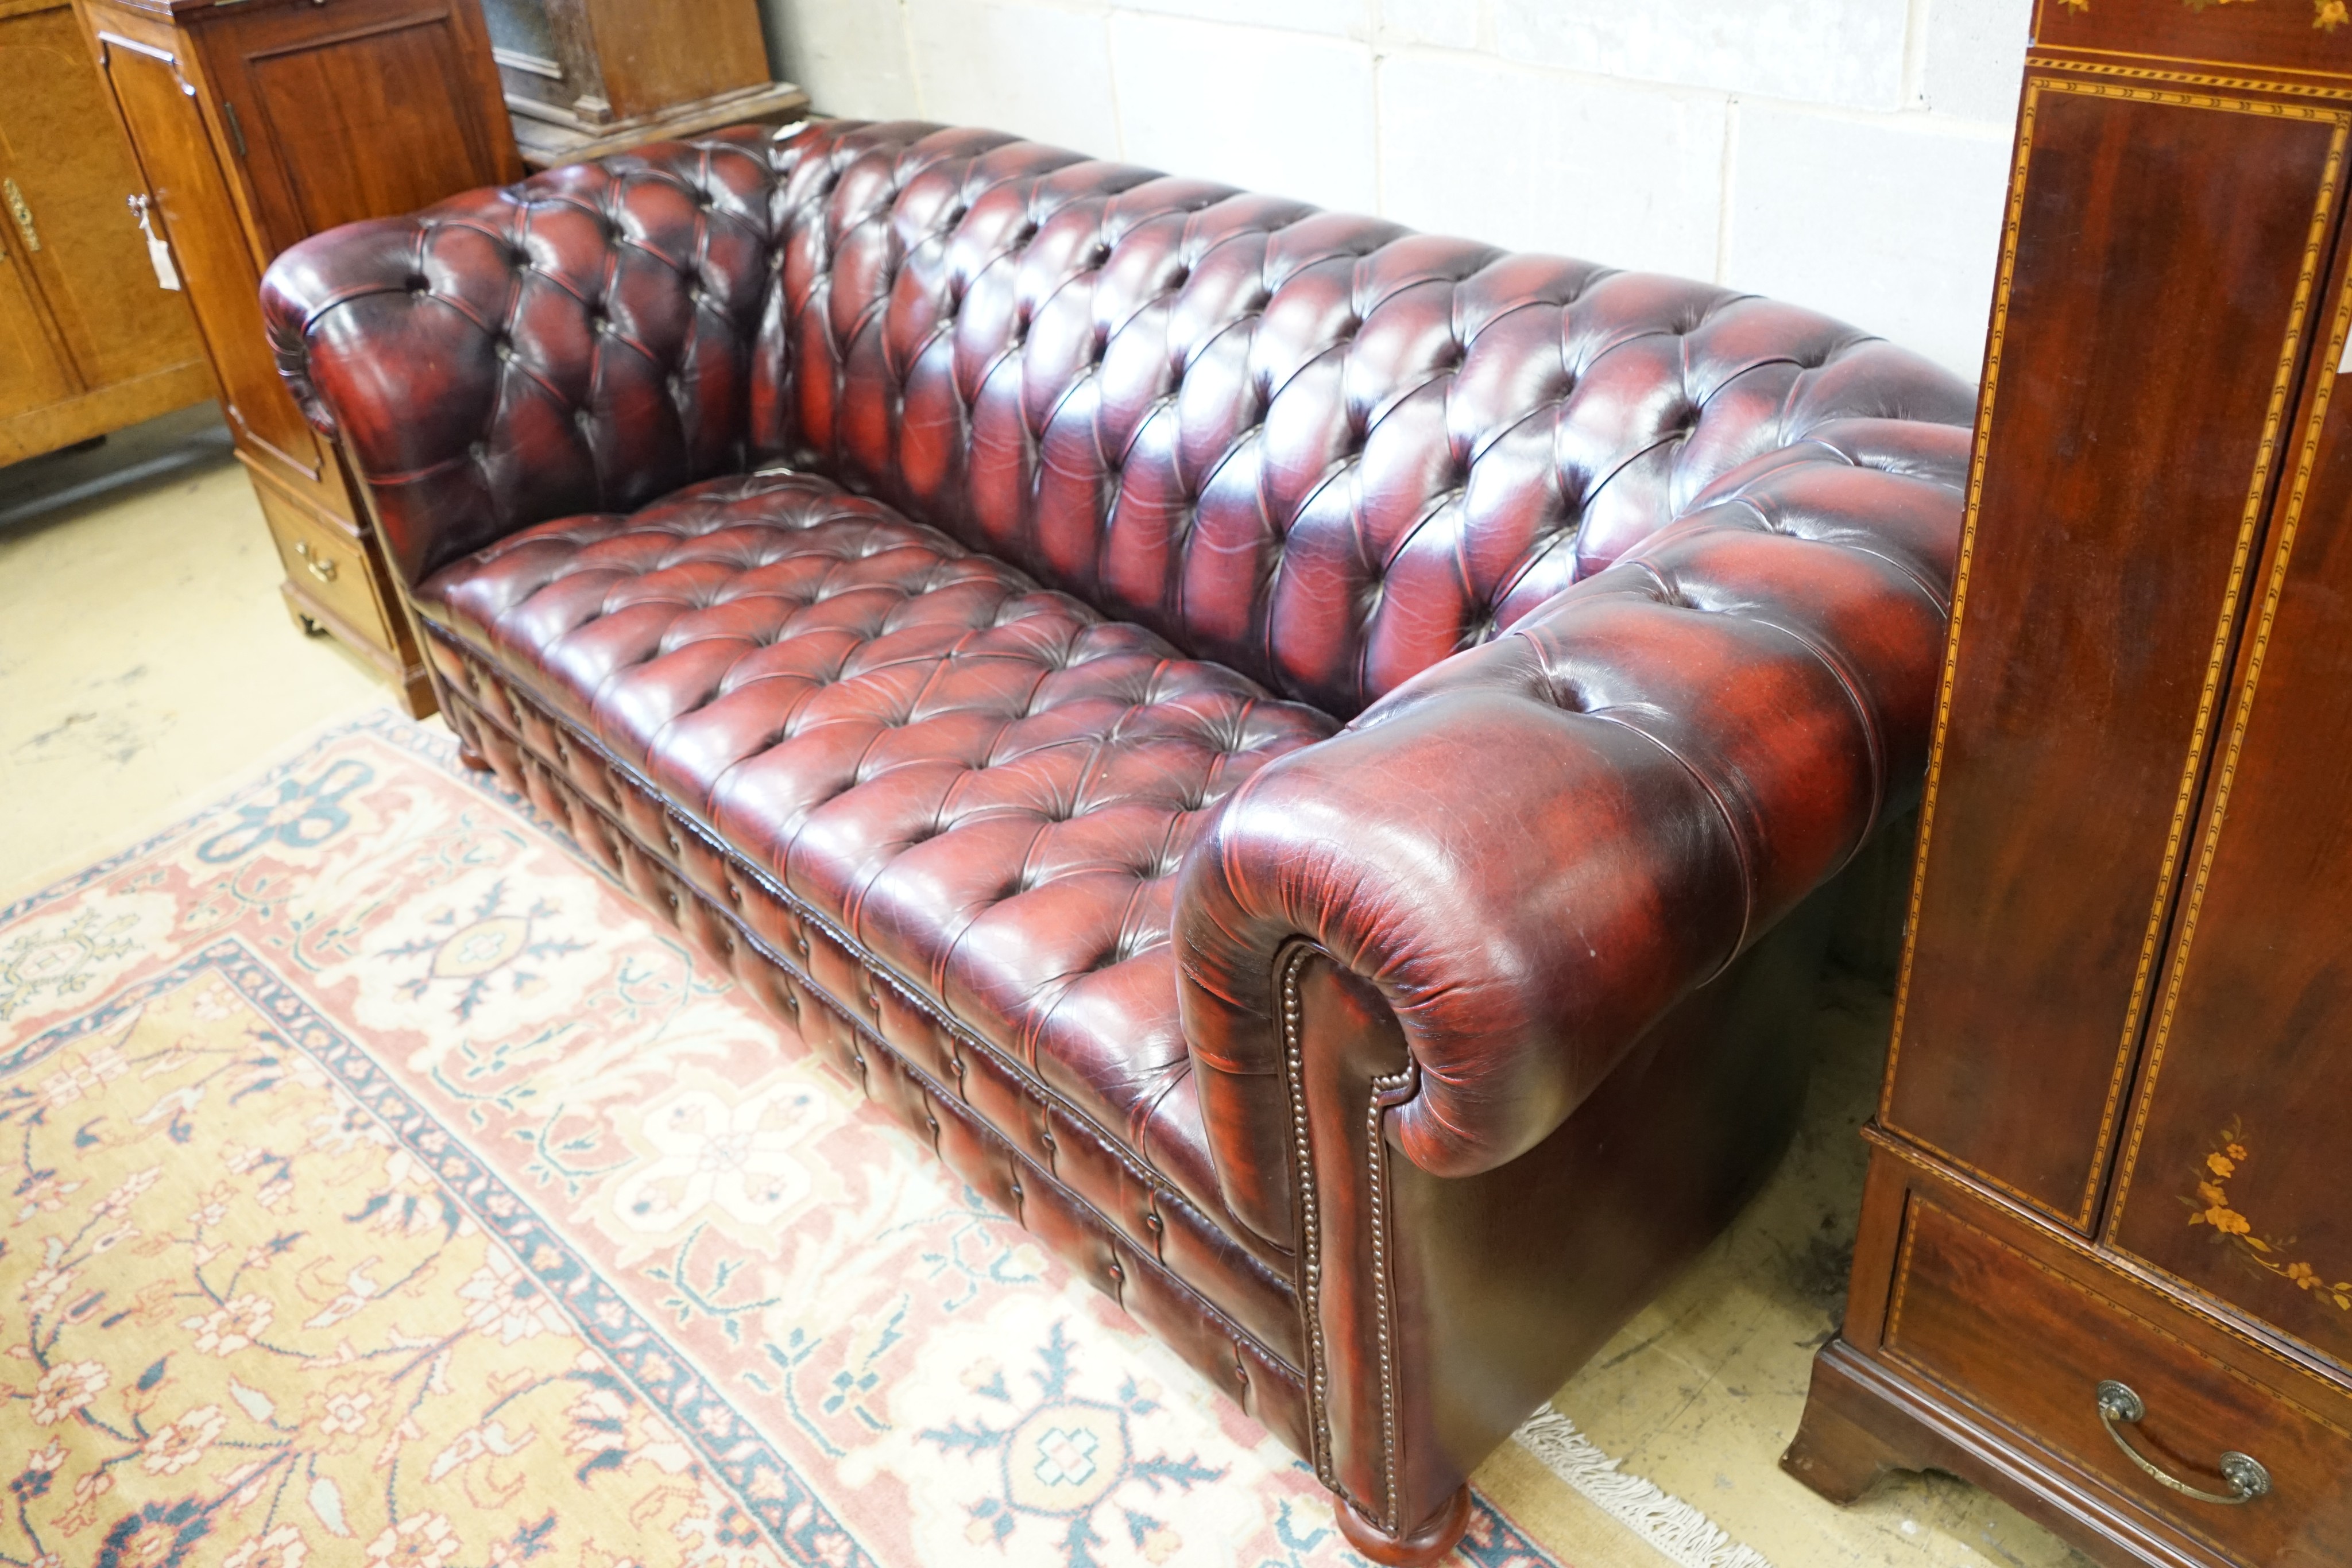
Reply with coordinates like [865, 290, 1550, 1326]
[0, 406, 2088, 1568]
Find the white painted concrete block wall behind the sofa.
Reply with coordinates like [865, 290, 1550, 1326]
[762, 0, 2032, 378]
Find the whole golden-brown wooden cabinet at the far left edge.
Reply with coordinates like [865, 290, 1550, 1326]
[0, 0, 212, 463]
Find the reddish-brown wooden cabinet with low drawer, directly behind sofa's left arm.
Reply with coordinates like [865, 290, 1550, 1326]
[75, 0, 522, 715]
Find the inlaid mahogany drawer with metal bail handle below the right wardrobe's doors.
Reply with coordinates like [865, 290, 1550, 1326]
[1882, 1190, 2352, 1568]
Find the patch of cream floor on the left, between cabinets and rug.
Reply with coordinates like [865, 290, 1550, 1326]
[0, 404, 386, 898]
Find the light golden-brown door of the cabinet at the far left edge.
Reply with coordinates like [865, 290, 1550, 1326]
[0, 2, 202, 388]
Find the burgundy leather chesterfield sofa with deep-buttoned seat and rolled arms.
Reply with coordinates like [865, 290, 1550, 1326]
[266, 122, 1974, 1563]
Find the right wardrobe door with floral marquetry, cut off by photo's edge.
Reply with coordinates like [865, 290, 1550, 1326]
[2107, 276, 2352, 1368]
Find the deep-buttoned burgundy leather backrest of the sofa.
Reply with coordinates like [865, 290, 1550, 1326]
[753, 120, 1971, 715]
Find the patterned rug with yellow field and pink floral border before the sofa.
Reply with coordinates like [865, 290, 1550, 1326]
[0, 715, 1554, 1568]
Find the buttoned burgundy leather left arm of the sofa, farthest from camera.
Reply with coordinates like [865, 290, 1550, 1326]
[261, 127, 795, 583]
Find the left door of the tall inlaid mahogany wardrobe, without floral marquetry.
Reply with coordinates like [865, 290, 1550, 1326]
[1882, 64, 2352, 1232]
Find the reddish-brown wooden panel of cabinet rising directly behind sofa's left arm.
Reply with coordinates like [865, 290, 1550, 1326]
[204, 0, 522, 254]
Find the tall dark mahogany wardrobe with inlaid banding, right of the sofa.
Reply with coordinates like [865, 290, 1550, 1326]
[1783, 0, 2352, 1566]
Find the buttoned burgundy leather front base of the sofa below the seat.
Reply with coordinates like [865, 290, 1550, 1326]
[433, 637, 1305, 1382]
